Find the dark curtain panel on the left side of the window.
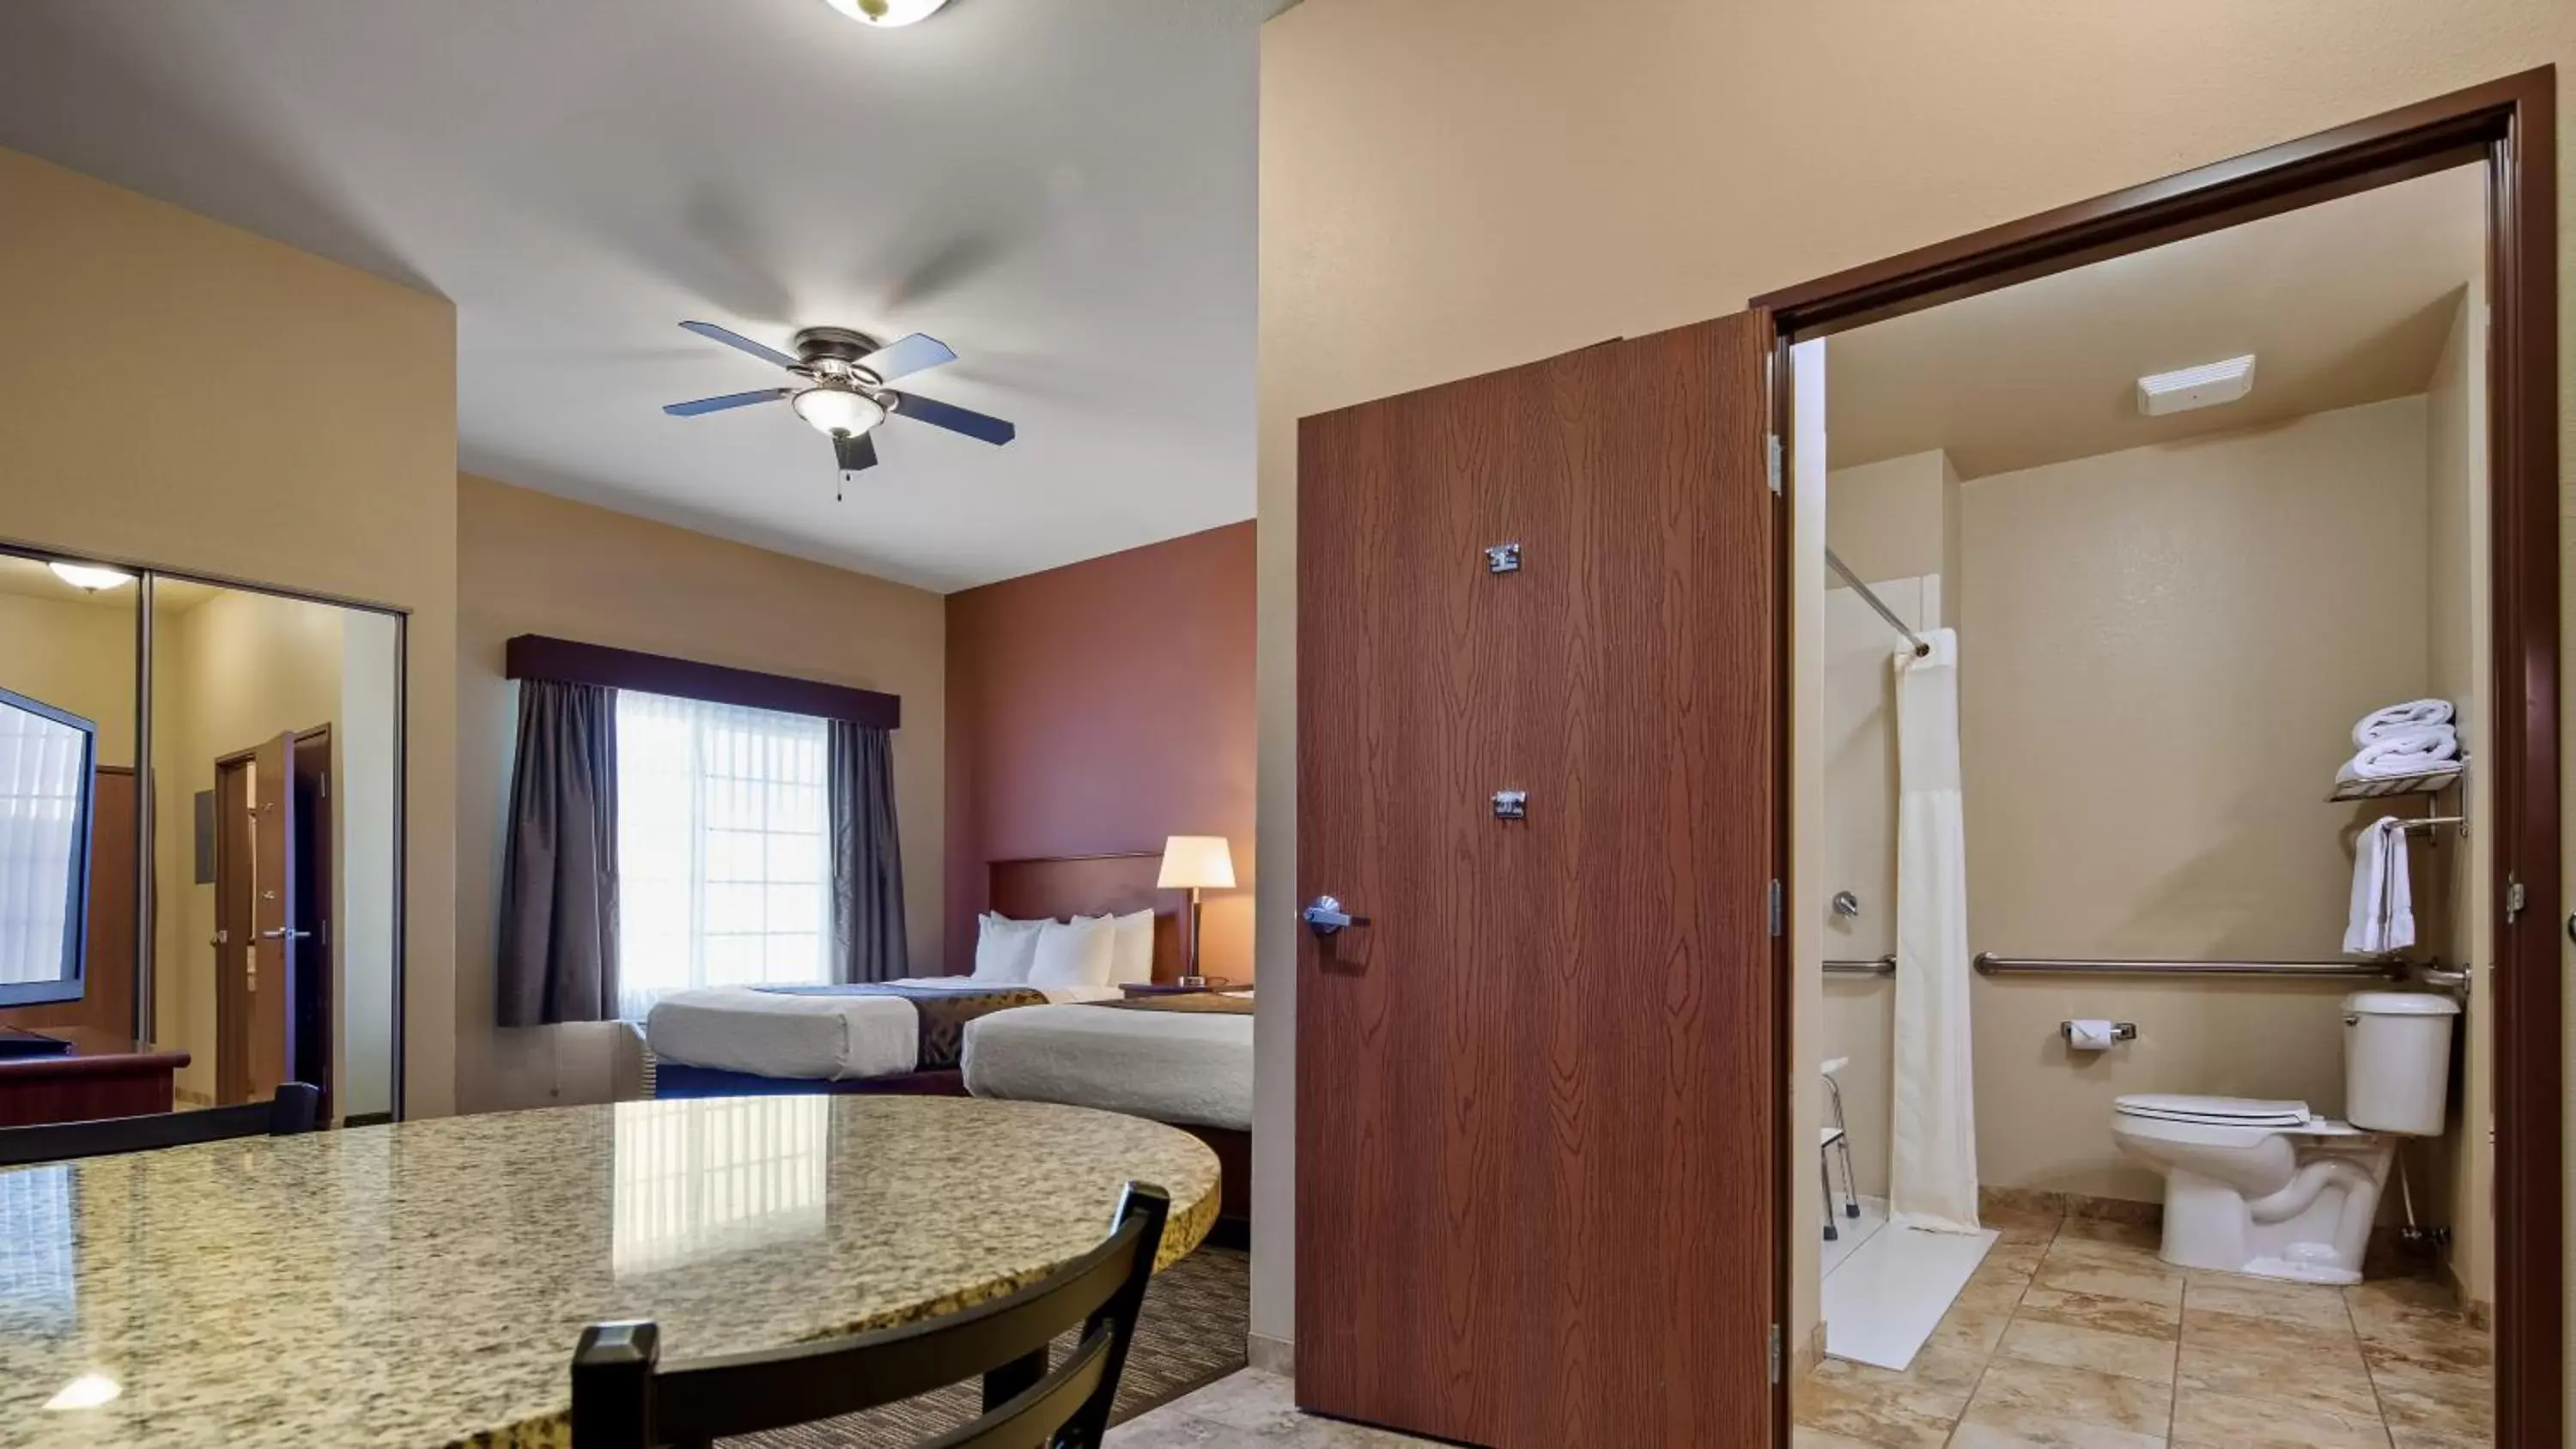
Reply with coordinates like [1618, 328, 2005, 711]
[500, 680, 618, 1027]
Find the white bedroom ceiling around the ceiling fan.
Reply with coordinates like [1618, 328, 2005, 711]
[0, 0, 1283, 590]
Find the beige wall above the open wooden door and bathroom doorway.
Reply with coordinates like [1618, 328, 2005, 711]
[1255, 0, 2576, 1379]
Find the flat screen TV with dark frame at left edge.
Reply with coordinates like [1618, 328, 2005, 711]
[0, 688, 98, 1006]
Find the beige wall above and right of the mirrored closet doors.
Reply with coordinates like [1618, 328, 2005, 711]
[0, 152, 456, 1114]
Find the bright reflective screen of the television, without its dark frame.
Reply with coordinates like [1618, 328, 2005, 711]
[0, 708, 88, 983]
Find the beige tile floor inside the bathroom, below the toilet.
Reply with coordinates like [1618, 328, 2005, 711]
[1795, 1217, 2494, 1449]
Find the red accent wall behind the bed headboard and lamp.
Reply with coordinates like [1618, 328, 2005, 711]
[945, 523, 1255, 980]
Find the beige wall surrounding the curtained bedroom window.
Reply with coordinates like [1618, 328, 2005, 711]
[456, 476, 945, 1112]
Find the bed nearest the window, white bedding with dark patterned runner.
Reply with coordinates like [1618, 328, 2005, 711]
[644, 975, 1118, 1083]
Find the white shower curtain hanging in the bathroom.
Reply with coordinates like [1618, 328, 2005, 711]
[1888, 628, 1978, 1233]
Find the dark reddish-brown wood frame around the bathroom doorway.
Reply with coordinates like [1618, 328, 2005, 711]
[1754, 67, 2576, 1444]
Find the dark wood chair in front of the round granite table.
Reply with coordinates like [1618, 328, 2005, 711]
[572, 1181, 1172, 1449]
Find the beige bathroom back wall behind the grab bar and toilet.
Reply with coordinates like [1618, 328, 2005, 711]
[1960, 397, 2434, 1199]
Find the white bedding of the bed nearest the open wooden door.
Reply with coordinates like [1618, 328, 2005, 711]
[963, 991, 1252, 1132]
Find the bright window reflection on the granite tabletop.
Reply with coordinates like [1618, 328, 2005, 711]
[608, 1096, 832, 1276]
